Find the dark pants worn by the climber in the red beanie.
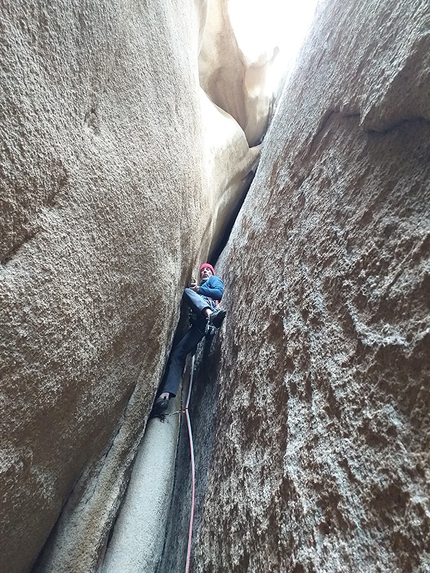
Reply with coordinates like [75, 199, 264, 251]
[163, 288, 210, 396]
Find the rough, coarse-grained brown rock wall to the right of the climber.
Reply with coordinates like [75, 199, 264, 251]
[193, 0, 430, 573]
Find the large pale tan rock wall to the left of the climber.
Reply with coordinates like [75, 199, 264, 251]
[0, 0, 256, 573]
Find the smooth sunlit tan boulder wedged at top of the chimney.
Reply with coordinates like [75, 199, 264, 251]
[199, 0, 277, 146]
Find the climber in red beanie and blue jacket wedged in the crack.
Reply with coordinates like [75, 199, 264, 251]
[152, 263, 226, 416]
